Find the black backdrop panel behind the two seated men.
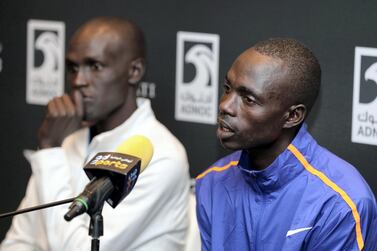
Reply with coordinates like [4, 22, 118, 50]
[0, 0, 377, 239]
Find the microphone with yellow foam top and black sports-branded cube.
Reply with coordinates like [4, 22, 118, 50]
[64, 135, 153, 221]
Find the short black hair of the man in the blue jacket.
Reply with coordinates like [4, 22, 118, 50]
[252, 38, 321, 112]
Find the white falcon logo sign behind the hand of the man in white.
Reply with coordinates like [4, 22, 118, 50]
[26, 20, 65, 105]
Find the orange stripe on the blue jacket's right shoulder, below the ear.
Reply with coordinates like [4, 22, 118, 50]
[288, 144, 364, 250]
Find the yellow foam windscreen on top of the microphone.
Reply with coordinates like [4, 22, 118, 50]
[116, 135, 153, 173]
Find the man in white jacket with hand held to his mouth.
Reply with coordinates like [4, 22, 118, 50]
[0, 18, 189, 251]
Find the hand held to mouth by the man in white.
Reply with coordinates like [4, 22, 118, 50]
[38, 90, 84, 149]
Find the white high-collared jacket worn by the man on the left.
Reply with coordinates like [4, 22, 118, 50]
[0, 99, 189, 251]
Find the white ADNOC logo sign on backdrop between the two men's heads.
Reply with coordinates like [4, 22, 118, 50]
[175, 31, 220, 124]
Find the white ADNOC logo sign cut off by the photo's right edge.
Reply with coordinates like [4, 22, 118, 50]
[352, 47, 377, 145]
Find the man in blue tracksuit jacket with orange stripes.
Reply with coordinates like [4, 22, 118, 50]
[196, 39, 377, 251]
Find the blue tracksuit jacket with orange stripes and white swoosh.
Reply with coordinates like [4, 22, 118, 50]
[196, 125, 377, 251]
